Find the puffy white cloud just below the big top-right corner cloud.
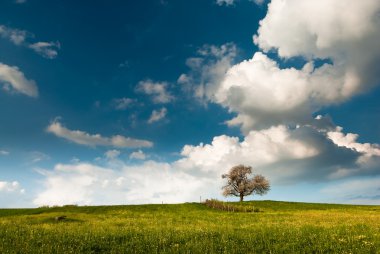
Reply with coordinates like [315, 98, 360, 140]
[217, 52, 359, 132]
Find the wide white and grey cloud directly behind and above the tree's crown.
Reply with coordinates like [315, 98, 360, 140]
[176, 118, 380, 184]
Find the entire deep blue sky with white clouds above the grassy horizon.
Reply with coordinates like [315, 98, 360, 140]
[0, 0, 380, 207]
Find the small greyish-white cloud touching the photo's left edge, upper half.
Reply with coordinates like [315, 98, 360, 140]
[0, 63, 38, 97]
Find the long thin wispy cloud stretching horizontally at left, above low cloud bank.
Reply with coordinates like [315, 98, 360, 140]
[46, 120, 153, 148]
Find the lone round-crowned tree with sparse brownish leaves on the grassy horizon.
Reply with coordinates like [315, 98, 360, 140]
[222, 165, 270, 202]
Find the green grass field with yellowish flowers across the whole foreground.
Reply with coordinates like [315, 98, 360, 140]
[0, 201, 380, 253]
